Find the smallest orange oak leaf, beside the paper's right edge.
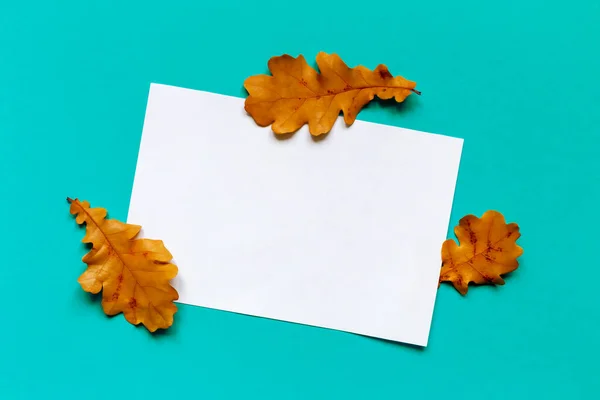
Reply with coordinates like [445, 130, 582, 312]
[440, 211, 523, 295]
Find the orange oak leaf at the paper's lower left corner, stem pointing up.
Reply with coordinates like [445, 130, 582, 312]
[67, 198, 179, 332]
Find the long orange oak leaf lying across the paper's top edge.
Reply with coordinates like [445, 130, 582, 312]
[244, 52, 421, 136]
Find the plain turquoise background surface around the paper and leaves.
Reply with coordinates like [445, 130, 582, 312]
[0, 0, 600, 399]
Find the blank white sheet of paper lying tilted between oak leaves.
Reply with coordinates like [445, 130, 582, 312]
[128, 84, 463, 346]
